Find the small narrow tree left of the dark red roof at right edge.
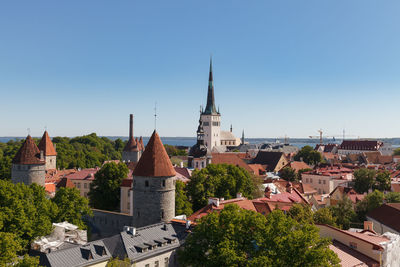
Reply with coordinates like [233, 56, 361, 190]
[329, 196, 356, 229]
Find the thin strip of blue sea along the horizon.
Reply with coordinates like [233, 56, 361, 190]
[0, 136, 400, 148]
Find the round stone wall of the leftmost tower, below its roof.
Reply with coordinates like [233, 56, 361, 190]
[11, 164, 46, 186]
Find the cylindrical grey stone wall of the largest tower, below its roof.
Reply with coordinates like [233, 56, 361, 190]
[133, 176, 175, 227]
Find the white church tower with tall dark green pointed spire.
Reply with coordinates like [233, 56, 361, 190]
[201, 59, 221, 151]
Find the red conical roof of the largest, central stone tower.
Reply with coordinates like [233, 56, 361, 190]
[133, 130, 176, 177]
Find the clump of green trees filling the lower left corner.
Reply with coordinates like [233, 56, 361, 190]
[0, 180, 90, 266]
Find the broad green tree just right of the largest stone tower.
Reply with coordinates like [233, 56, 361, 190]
[187, 164, 255, 211]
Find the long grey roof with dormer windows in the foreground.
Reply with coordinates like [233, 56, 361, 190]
[30, 223, 188, 267]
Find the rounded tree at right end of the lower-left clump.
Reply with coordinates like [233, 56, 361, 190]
[52, 187, 92, 229]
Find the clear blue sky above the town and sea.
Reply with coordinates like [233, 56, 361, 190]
[0, 0, 400, 137]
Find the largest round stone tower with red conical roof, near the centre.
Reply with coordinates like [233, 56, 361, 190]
[132, 131, 176, 227]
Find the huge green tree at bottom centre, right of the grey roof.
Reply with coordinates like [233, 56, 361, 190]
[178, 205, 339, 267]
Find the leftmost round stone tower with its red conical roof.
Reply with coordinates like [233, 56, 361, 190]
[11, 135, 45, 186]
